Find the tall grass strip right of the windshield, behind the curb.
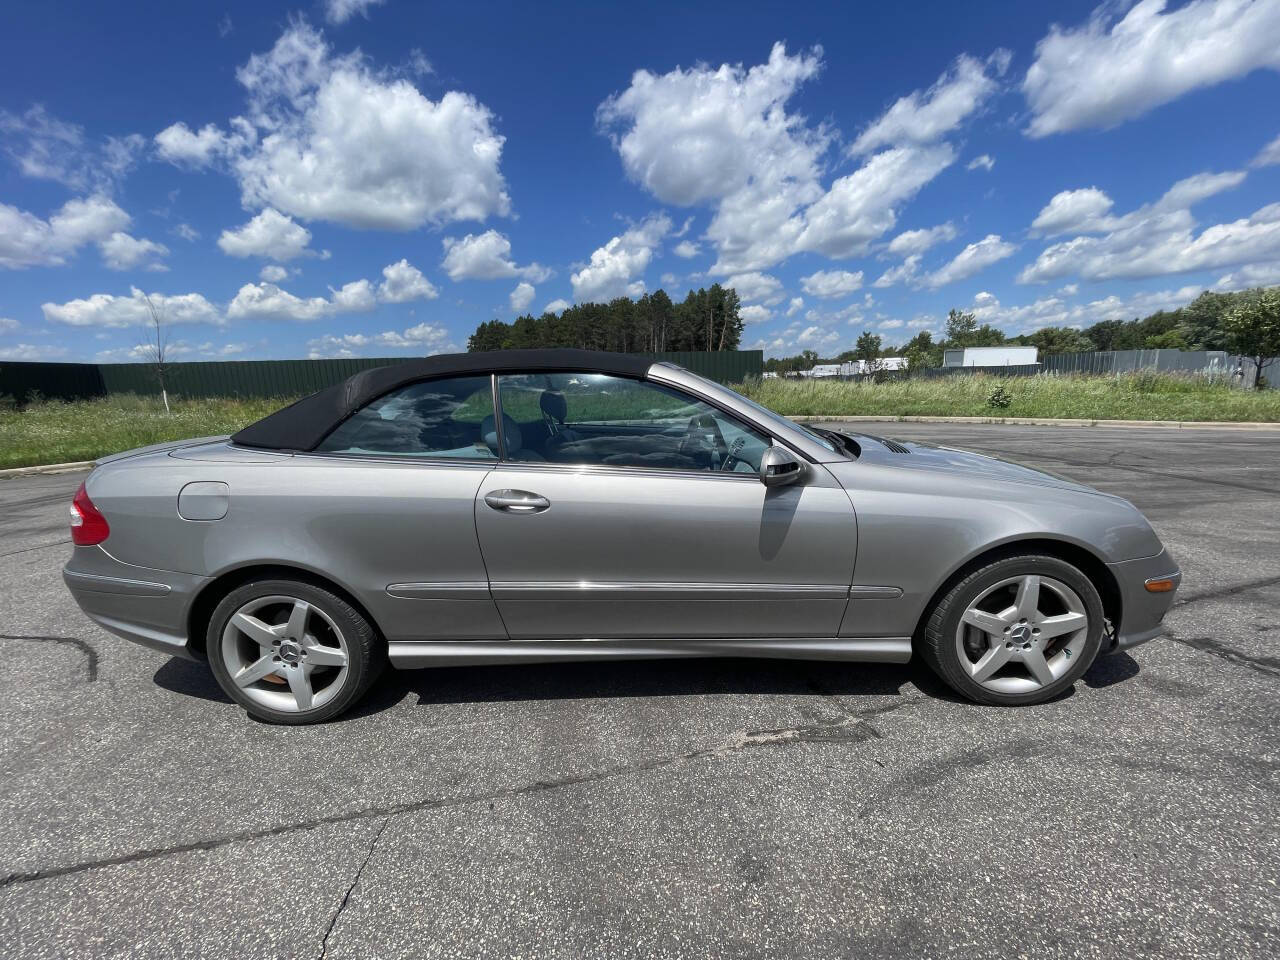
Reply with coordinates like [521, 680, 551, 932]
[735, 372, 1280, 422]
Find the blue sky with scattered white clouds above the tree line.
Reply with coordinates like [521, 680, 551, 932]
[0, 0, 1280, 361]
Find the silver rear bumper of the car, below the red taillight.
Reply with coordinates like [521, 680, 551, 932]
[63, 547, 209, 659]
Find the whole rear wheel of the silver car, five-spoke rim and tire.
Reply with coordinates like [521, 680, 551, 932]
[206, 580, 383, 724]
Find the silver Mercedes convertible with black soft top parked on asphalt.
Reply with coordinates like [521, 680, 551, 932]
[63, 349, 1180, 723]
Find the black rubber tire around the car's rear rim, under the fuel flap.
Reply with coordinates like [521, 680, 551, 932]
[205, 580, 387, 726]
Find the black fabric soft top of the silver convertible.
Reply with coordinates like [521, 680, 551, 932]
[232, 349, 654, 451]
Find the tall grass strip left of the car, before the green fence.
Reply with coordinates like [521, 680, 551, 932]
[0, 393, 291, 467]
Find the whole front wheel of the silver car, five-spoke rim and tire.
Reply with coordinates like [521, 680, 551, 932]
[922, 556, 1103, 707]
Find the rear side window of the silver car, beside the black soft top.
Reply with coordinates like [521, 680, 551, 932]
[317, 376, 498, 460]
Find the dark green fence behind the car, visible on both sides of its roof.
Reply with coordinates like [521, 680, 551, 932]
[0, 349, 764, 403]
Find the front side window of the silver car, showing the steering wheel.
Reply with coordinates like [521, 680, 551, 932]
[498, 374, 769, 472]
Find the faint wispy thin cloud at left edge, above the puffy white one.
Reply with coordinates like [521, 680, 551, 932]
[0, 104, 146, 193]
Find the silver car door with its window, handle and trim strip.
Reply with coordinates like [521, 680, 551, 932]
[475, 372, 858, 639]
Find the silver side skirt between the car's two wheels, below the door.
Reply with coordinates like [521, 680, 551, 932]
[387, 636, 911, 669]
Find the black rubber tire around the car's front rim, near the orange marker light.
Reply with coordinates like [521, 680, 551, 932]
[916, 554, 1105, 707]
